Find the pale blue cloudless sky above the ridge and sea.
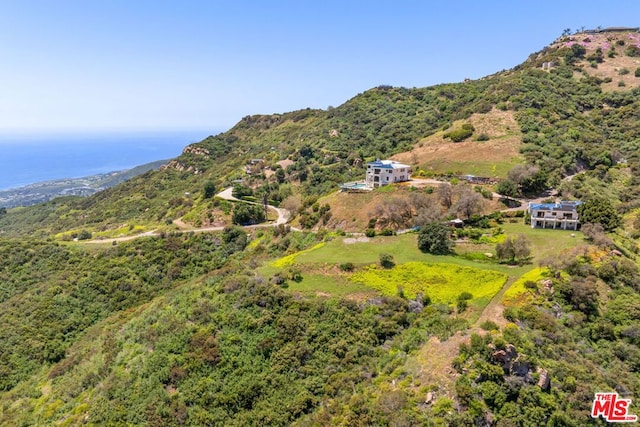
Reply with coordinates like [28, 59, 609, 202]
[0, 0, 640, 132]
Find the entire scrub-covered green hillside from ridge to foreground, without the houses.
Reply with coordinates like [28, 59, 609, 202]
[0, 30, 640, 426]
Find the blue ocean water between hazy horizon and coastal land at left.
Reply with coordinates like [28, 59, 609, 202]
[0, 131, 218, 190]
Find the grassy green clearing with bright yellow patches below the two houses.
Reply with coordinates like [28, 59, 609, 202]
[259, 223, 583, 306]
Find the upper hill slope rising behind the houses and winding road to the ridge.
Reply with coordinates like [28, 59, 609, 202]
[0, 29, 640, 235]
